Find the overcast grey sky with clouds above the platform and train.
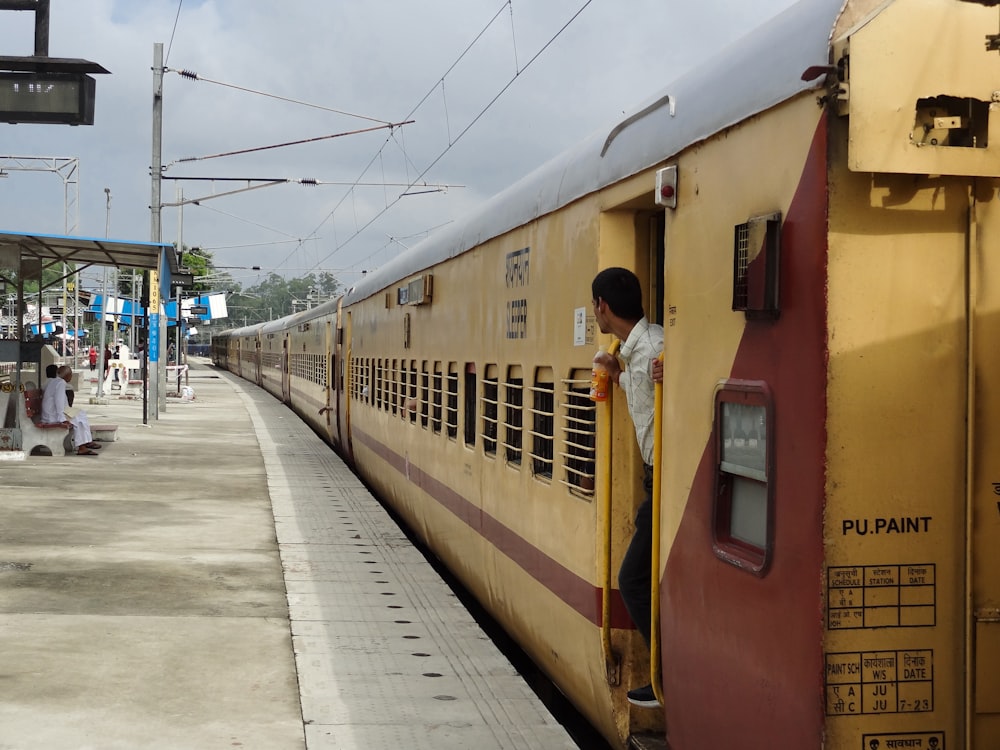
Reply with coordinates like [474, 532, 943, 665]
[0, 0, 794, 286]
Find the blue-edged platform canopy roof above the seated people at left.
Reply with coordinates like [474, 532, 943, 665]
[0, 231, 177, 275]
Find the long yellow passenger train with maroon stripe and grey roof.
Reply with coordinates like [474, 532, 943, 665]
[213, 0, 1000, 750]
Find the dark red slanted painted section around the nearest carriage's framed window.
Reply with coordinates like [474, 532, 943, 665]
[660, 119, 829, 750]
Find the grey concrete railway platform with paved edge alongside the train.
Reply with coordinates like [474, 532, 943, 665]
[0, 361, 577, 750]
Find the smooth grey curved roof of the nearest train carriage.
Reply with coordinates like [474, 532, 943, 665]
[345, 0, 849, 303]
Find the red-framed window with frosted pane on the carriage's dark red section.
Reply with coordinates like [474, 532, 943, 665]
[713, 381, 774, 575]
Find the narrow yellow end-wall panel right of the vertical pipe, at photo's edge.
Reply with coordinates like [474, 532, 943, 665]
[968, 179, 1000, 749]
